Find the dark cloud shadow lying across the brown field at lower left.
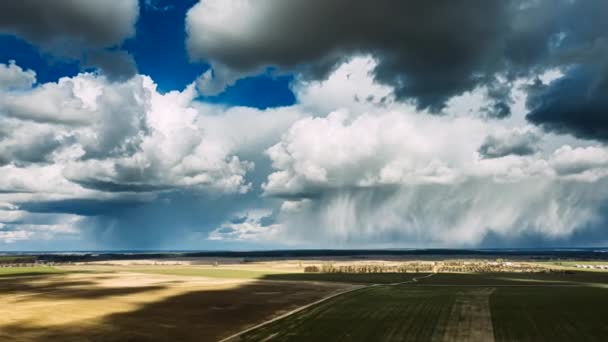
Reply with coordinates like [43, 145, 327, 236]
[0, 281, 337, 342]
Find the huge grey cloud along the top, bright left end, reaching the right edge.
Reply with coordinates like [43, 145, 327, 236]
[186, 0, 608, 118]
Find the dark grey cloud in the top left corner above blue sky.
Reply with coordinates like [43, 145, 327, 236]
[0, 0, 139, 78]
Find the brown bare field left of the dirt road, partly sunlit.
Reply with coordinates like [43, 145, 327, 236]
[0, 268, 350, 341]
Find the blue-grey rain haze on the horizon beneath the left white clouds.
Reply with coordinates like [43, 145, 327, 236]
[76, 192, 273, 249]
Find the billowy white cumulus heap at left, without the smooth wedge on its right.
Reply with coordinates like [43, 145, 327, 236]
[0, 74, 268, 198]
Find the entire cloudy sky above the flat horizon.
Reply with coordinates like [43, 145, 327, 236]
[0, 0, 608, 251]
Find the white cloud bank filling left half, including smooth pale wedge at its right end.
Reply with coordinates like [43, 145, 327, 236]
[0, 60, 301, 208]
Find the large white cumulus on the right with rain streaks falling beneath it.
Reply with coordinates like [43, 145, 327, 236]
[253, 57, 608, 247]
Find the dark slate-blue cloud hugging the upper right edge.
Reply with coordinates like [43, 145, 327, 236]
[527, 0, 608, 142]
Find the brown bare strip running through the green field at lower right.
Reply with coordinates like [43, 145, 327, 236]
[432, 288, 494, 342]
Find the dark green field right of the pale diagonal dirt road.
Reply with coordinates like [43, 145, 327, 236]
[240, 272, 608, 342]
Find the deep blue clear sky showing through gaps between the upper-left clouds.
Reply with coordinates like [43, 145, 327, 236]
[0, 1, 295, 108]
